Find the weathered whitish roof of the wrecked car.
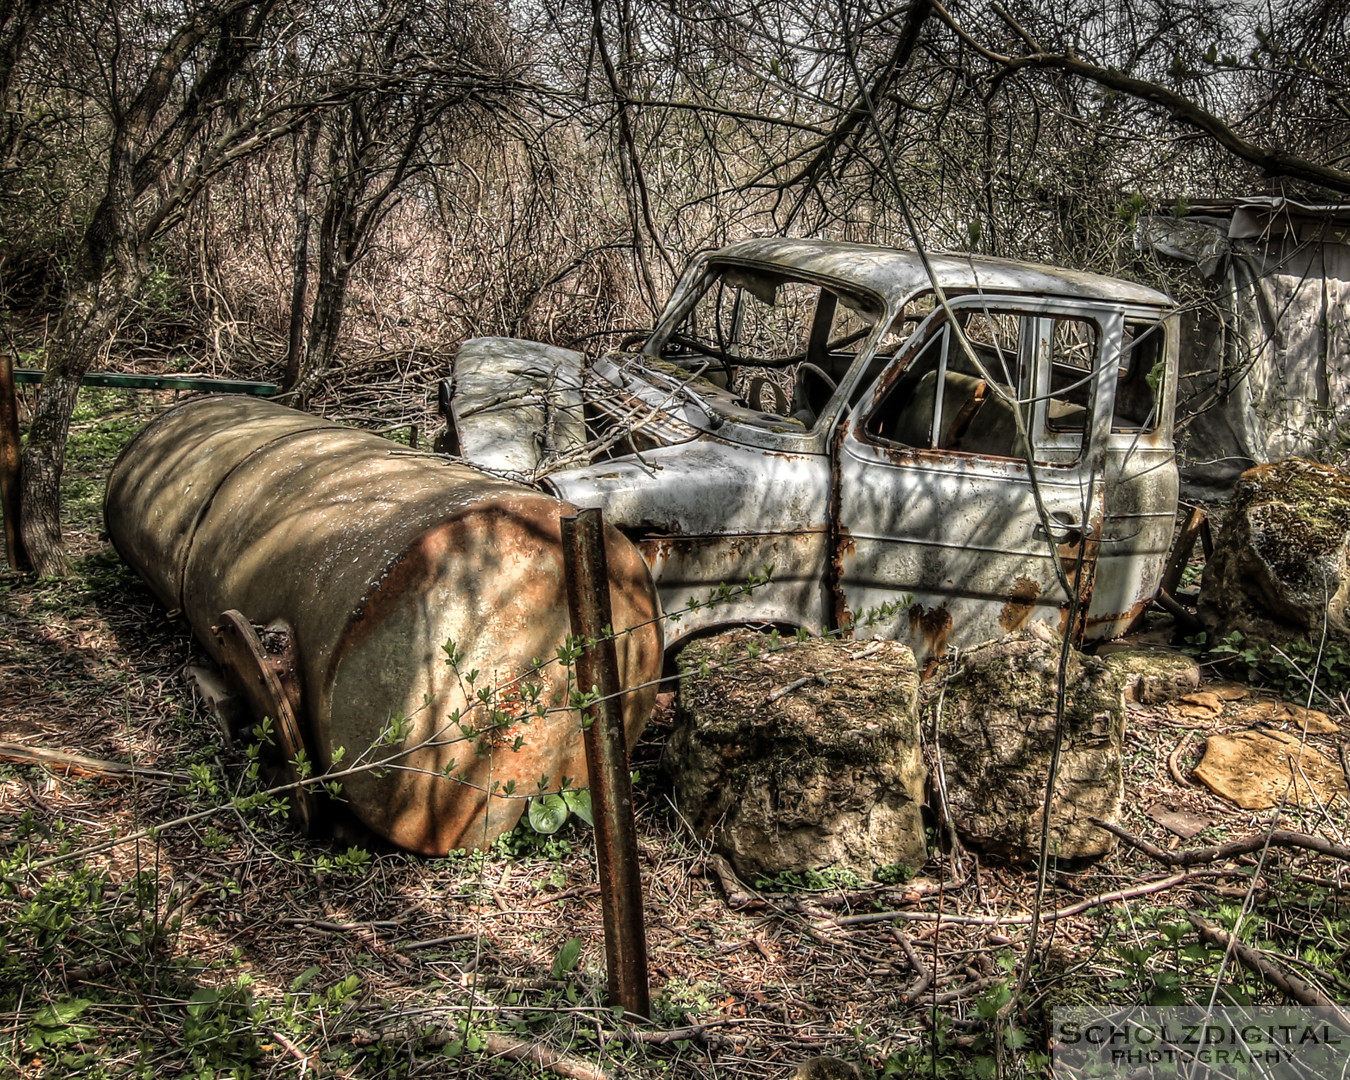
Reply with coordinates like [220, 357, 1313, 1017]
[711, 238, 1173, 308]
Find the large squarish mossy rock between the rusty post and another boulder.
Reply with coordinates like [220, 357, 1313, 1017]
[666, 630, 927, 879]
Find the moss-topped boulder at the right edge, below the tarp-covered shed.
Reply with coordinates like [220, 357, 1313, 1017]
[1200, 458, 1350, 643]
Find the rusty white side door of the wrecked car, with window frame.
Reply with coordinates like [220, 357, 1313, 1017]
[834, 297, 1121, 663]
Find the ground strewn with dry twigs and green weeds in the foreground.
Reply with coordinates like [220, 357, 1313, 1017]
[0, 392, 1350, 1080]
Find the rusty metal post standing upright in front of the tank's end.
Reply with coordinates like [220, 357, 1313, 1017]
[562, 508, 651, 1017]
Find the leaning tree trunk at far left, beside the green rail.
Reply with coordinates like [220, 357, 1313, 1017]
[22, 0, 303, 575]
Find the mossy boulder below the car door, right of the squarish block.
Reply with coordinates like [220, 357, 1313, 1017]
[925, 622, 1125, 860]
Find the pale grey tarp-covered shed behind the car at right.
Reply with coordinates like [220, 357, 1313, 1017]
[1139, 198, 1350, 494]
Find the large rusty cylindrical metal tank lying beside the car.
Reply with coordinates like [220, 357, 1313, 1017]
[104, 397, 663, 855]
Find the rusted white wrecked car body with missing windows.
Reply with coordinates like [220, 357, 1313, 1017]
[440, 239, 1177, 662]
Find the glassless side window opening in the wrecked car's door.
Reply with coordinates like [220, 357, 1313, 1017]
[864, 308, 1100, 463]
